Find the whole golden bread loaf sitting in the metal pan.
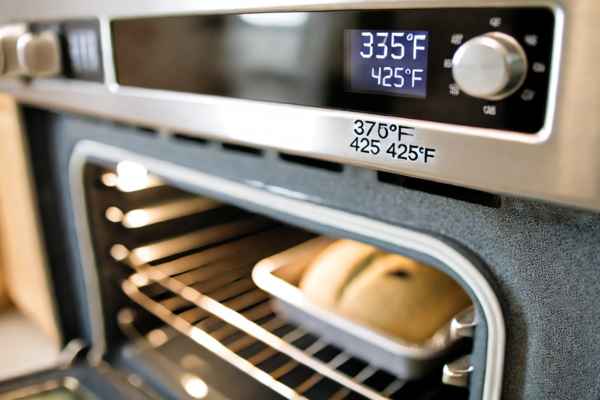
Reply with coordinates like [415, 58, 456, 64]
[300, 240, 470, 344]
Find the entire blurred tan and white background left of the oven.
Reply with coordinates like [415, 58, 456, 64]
[0, 95, 60, 381]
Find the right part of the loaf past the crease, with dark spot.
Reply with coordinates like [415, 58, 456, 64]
[337, 255, 470, 344]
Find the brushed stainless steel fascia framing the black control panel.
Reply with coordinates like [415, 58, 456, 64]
[0, 0, 600, 210]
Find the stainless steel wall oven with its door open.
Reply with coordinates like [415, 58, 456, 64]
[0, 0, 600, 400]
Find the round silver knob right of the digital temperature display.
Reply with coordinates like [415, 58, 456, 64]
[452, 32, 527, 100]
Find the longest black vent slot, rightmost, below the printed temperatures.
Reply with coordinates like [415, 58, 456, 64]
[377, 171, 502, 208]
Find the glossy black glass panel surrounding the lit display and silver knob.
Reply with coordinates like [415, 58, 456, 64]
[112, 8, 554, 133]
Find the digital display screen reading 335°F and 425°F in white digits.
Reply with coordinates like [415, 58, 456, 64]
[345, 29, 429, 98]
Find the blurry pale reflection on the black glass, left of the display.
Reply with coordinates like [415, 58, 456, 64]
[223, 13, 336, 103]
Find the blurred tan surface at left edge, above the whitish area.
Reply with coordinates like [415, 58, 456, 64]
[0, 95, 60, 343]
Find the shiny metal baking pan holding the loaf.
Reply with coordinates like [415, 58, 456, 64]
[252, 237, 472, 379]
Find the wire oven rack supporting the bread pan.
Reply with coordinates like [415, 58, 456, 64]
[122, 229, 406, 399]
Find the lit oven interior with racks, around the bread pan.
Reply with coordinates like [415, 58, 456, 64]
[84, 160, 482, 399]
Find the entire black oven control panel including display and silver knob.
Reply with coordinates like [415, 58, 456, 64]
[111, 8, 555, 133]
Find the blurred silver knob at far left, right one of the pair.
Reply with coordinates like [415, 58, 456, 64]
[17, 31, 61, 77]
